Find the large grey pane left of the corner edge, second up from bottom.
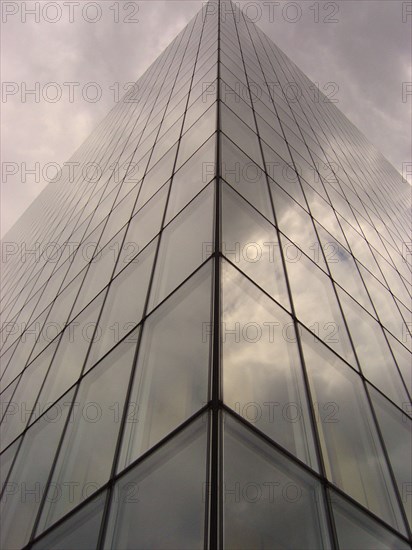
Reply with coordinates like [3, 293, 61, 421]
[120, 262, 212, 467]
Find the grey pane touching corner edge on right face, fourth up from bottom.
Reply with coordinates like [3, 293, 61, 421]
[220, 134, 273, 222]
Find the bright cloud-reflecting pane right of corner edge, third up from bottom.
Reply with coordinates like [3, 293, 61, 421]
[222, 184, 290, 309]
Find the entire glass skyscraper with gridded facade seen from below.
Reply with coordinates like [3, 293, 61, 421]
[0, 0, 412, 550]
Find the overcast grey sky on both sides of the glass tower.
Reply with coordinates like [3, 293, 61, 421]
[1, 0, 412, 235]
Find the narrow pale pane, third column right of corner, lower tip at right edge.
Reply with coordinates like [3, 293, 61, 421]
[339, 290, 408, 407]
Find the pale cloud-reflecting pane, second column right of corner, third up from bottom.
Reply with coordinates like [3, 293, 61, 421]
[283, 239, 355, 364]
